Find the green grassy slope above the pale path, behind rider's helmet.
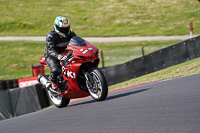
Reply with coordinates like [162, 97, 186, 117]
[0, 0, 200, 36]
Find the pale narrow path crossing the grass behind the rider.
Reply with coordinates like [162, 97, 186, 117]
[0, 35, 197, 42]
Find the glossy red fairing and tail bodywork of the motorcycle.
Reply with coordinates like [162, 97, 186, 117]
[39, 37, 99, 99]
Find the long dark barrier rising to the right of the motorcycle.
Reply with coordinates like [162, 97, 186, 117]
[102, 36, 200, 85]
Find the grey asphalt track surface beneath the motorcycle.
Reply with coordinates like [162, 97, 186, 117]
[0, 74, 200, 133]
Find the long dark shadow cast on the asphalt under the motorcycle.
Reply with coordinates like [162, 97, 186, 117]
[69, 88, 151, 106]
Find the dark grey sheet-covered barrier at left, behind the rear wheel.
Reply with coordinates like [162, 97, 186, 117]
[0, 84, 50, 120]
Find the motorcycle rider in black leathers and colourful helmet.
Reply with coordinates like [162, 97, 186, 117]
[45, 16, 76, 89]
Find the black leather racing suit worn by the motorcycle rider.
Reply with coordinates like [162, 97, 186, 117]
[45, 28, 76, 81]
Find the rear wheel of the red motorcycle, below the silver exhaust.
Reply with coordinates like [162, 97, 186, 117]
[47, 90, 70, 108]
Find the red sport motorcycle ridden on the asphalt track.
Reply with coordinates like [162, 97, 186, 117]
[38, 36, 108, 108]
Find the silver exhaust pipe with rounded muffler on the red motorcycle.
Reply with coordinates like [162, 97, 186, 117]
[37, 74, 60, 94]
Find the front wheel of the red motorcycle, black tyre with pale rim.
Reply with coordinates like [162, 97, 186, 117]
[86, 68, 108, 101]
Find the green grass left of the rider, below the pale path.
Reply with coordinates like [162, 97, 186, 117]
[0, 41, 45, 79]
